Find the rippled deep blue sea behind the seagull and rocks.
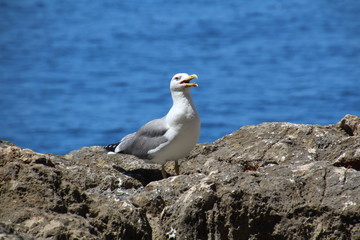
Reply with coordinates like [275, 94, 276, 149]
[0, 0, 360, 154]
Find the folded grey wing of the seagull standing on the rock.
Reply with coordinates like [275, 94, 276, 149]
[115, 118, 169, 159]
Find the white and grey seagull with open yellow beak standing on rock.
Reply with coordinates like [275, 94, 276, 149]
[104, 73, 200, 178]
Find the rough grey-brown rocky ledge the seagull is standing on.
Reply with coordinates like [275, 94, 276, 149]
[0, 115, 360, 240]
